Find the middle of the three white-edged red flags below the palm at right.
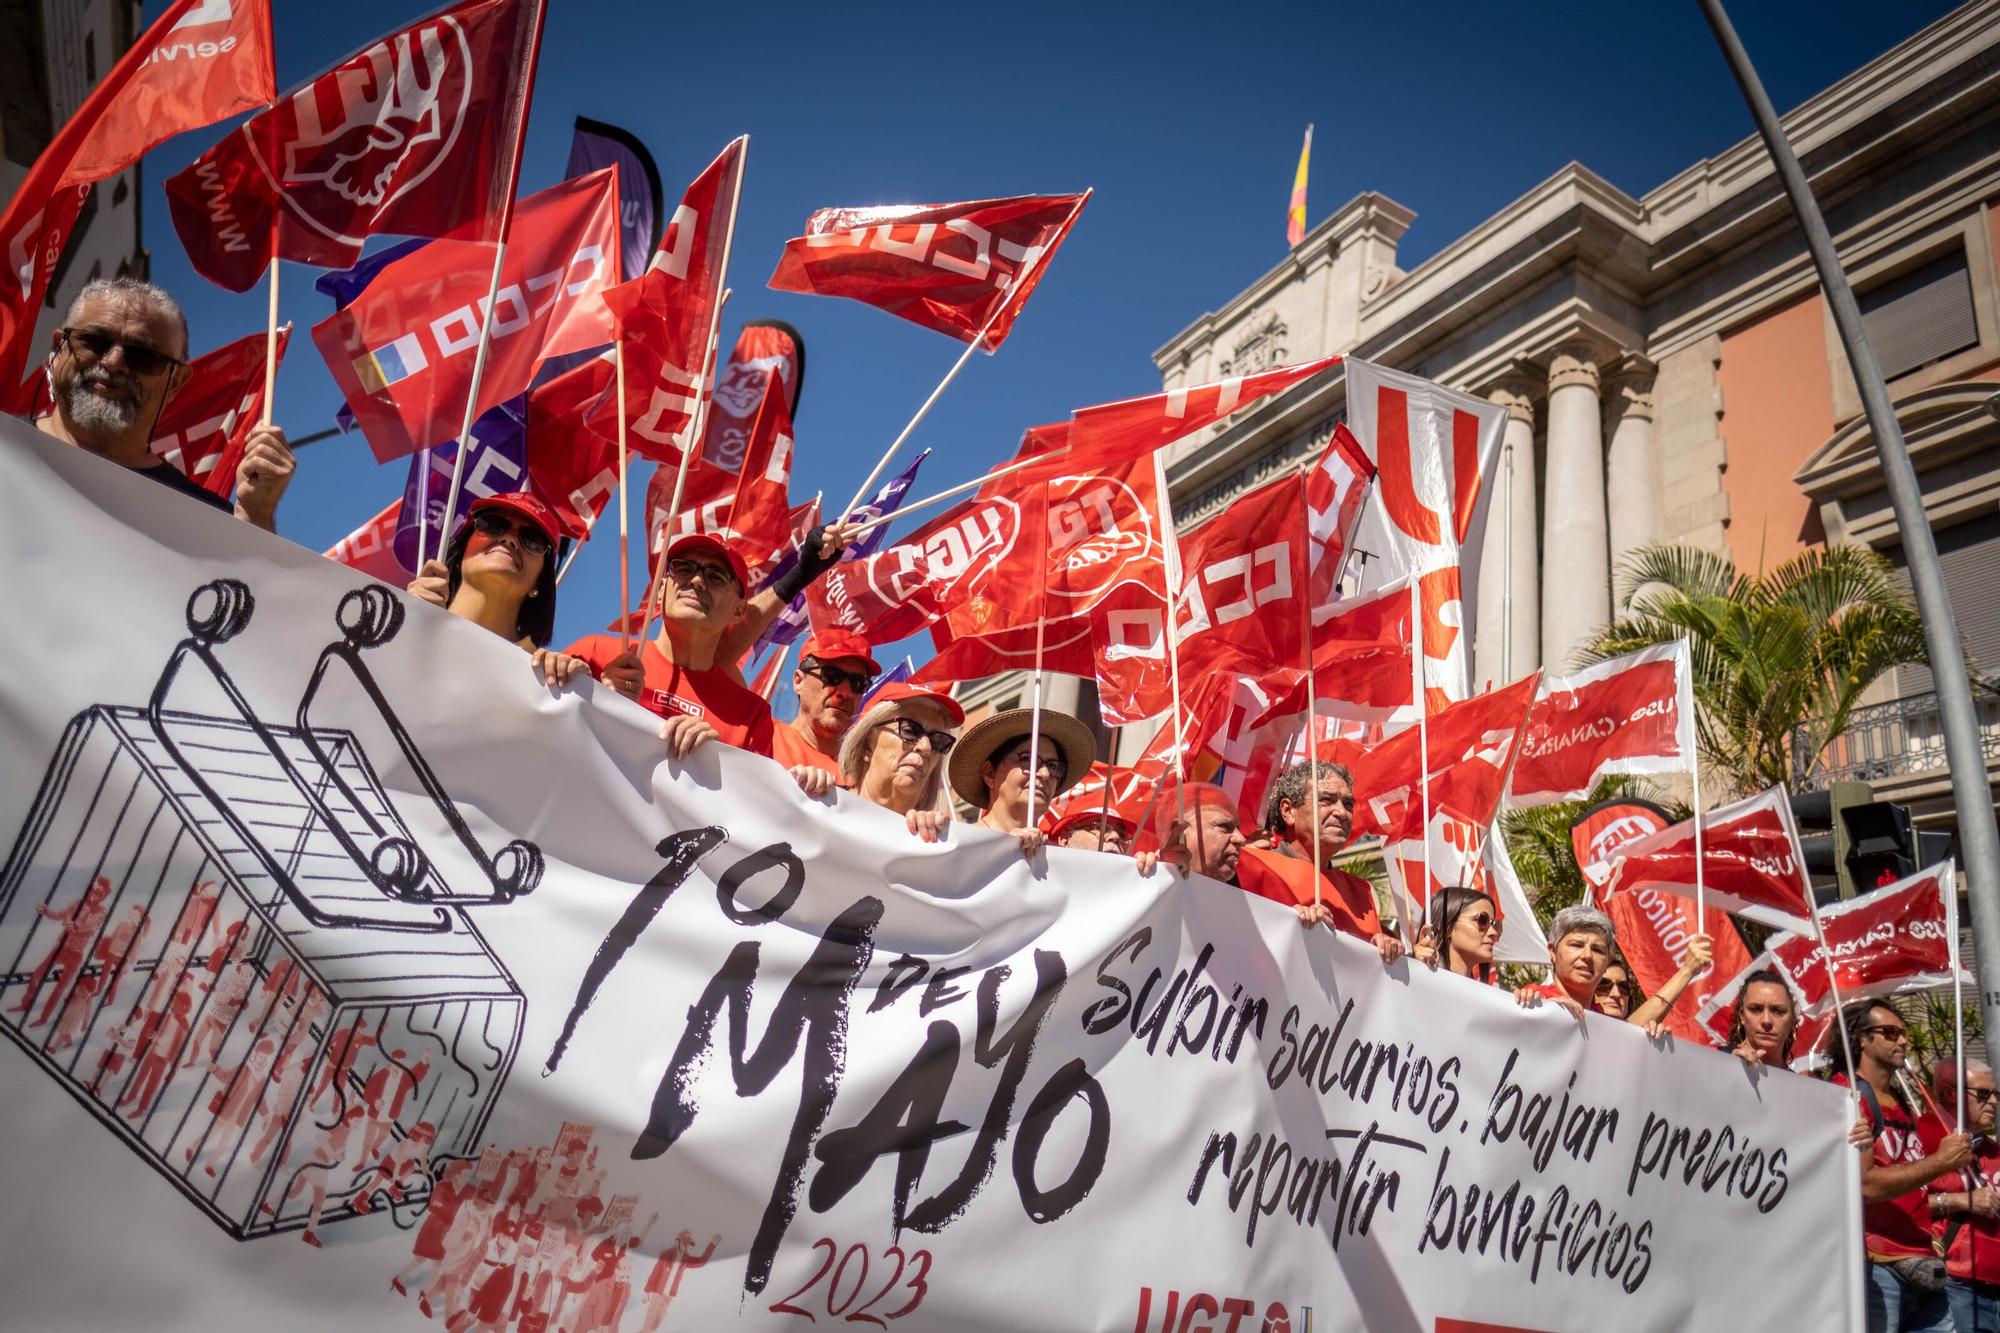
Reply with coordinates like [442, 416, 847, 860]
[1584, 787, 1812, 935]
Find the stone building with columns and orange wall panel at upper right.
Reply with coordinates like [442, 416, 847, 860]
[1024, 2, 2000, 819]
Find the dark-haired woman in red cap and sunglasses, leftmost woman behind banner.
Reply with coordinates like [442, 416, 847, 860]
[408, 490, 590, 687]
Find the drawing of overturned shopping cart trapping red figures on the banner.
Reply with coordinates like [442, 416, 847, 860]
[0, 580, 542, 1239]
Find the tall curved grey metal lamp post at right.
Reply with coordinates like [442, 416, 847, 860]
[1700, 0, 2000, 1033]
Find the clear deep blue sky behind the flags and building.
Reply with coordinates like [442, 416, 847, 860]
[142, 0, 1950, 717]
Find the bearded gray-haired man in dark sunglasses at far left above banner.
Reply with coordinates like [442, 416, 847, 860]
[36, 278, 294, 532]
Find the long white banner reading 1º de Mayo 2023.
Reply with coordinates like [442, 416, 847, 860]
[0, 422, 1860, 1333]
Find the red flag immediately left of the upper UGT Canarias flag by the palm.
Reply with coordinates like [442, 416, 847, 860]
[1352, 673, 1540, 841]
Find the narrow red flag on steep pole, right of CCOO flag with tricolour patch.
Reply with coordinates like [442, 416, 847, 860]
[598, 138, 748, 462]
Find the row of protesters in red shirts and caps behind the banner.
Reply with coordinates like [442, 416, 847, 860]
[36, 278, 2000, 1333]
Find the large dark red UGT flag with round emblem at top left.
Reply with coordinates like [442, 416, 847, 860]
[166, 0, 544, 292]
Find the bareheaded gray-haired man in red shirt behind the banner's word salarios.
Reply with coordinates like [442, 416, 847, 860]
[1236, 759, 1402, 963]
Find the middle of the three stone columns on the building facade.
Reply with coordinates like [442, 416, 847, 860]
[1542, 344, 1612, 673]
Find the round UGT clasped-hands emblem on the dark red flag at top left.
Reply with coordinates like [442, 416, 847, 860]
[280, 18, 472, 240]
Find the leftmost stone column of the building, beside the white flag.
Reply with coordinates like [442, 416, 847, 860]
[1472, 376, 1542, 687]
